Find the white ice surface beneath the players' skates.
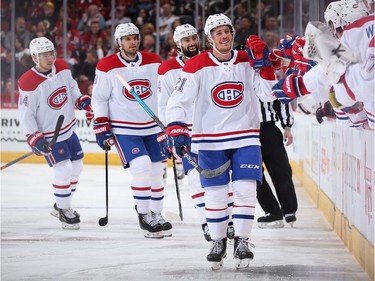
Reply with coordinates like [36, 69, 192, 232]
[0, 163, 369, 281]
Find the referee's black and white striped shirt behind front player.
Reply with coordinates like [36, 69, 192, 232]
[259, 100, 294, 129]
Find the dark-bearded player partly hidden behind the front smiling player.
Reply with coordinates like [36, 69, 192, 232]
[158, 24, 234, 241]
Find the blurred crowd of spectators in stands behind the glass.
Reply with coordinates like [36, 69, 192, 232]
[1, 0, 293, 107]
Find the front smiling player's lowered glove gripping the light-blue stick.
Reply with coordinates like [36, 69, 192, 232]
[166, 122, 190, 158]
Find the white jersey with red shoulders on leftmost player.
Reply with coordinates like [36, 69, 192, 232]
[18, 59, 81, 142]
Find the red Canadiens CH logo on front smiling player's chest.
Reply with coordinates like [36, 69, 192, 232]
[211, 82, 244, 108]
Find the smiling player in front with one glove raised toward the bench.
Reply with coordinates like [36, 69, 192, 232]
[166, 14, 276, 269]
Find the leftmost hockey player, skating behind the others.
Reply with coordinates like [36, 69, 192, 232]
[18, 37, 93, 229]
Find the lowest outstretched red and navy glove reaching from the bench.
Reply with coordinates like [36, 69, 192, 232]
[272, 74, 310, 104]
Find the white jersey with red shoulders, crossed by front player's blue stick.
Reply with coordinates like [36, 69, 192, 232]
[91, 52, 161, 136]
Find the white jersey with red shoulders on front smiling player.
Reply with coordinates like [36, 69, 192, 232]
[166, 51, 277, 152]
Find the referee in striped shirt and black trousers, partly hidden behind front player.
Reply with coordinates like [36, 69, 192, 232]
[257, 100, 298, 228]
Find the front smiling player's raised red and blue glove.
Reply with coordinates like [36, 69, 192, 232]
[246, 35, 272, 69]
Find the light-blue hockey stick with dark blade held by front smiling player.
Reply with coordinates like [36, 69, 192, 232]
[116, 73, 231, 178]
